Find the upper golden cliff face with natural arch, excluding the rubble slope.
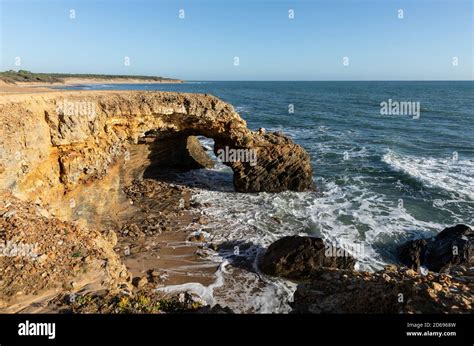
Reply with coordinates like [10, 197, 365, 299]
[0, 91, 312, 200]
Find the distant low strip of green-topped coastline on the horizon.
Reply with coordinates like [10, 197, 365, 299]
[0, 70, 178, 83]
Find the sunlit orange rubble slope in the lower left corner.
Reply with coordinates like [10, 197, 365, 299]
[0, 190, 130, 313]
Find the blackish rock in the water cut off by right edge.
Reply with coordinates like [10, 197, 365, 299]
[398, 225, 474, 272]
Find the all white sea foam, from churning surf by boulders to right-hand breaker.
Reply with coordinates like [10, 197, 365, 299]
[159, 140, 474, 313]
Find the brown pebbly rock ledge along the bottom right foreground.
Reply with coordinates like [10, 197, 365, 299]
[293, 266, 474, 314]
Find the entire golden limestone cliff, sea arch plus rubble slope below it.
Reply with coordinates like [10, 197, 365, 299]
[0, 91, 312, 312]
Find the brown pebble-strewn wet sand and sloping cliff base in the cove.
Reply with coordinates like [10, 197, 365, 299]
[54, 144, 217, 294]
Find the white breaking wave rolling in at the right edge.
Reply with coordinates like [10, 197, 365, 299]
[382, 150, 474, 200]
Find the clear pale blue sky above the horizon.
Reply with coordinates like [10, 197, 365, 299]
[0, 0, 474, 80]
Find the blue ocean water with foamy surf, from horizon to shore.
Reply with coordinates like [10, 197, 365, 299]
[61, 82, 474, 312]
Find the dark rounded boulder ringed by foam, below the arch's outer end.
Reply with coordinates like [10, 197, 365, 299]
[259, 236, 355, 280]
